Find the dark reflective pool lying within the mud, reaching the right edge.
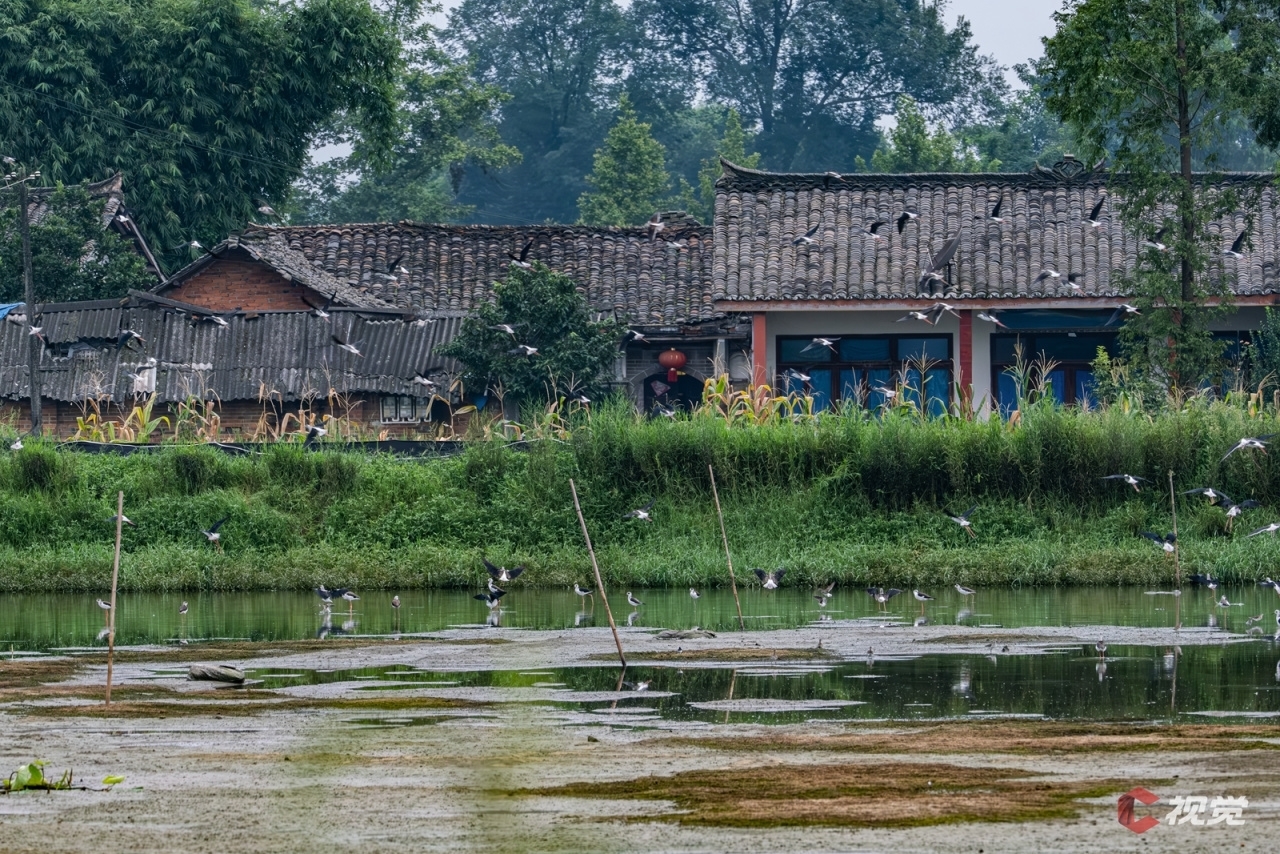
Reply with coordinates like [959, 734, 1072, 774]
[238, 640, 1280, 727]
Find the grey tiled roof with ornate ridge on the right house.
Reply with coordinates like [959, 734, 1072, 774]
[713, 159, 1280, 302]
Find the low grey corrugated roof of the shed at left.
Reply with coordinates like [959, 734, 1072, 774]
[0, 294, 462, 402]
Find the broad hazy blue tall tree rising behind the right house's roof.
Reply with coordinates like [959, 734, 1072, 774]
[634, 0, 1004, 169]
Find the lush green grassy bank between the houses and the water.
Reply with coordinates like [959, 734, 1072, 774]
[0, 405, 1280, 592]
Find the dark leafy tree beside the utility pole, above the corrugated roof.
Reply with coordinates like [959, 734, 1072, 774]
[0, 184, 156, 302]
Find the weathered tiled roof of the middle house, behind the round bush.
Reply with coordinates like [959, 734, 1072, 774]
[242, 214, 723, 326]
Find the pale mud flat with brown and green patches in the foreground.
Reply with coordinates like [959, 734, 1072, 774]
[0, 624, 1280, 854]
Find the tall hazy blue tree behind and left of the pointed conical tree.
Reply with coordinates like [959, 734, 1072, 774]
[443, 0, 627, 223]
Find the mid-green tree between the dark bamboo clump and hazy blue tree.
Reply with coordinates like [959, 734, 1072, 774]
[291, 0, 520, 223]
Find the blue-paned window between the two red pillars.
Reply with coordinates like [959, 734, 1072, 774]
[778, 335, 951, 415]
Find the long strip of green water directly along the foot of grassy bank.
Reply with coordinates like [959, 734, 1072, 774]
[0, 585, 1280, 653]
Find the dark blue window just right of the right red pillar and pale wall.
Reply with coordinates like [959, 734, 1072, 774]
[991, 330, 1116, 416]
